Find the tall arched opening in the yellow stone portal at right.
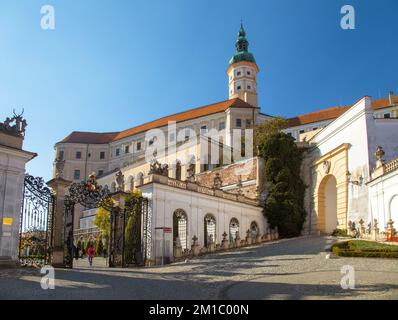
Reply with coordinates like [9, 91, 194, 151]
[318, 175, 338, 233]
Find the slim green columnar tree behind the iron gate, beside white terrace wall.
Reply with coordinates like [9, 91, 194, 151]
[124, 191, 142, 264]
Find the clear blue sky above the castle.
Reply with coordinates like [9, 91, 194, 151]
[0, 0, 398, 179]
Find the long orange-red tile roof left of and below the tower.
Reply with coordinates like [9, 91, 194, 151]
[60, 98, 254, 143]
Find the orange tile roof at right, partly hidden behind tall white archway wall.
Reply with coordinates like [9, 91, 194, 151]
[288, 96, 398, 127]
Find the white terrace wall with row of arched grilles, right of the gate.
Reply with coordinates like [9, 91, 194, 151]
[141, 183, 268, 261]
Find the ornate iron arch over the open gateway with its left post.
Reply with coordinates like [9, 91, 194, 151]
[64, 174, 113, 268]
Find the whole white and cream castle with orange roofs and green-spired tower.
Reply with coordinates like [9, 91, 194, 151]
[53, 25, 398, 260]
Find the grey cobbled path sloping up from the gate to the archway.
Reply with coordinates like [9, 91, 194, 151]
[0, 237, 398, 300]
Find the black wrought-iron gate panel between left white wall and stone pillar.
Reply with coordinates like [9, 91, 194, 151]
[19, 174, 55, 266]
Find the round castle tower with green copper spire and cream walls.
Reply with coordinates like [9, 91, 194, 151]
[227, 24, 259, 107]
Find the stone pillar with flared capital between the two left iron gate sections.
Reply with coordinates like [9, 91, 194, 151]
[47, 178, 72, 267]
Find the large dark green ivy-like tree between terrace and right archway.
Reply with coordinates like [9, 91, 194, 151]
[258, 127, 306, 237]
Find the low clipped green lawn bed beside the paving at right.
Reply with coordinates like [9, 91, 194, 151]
[332, 240, 398, 259]
